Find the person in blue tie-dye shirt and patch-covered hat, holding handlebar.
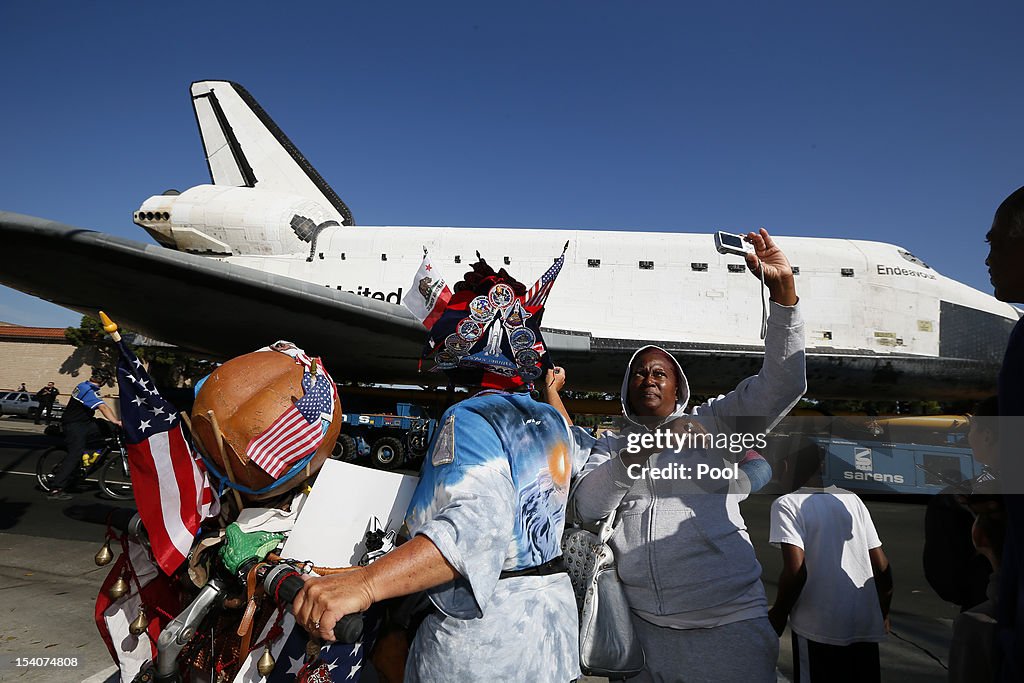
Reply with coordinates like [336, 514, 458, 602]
[294, 253, 588, 683]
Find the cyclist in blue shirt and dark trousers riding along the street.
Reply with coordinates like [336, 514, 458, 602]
[49, 370, 121, 501]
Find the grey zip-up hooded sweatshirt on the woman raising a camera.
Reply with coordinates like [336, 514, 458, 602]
[572, 302, 807, 629]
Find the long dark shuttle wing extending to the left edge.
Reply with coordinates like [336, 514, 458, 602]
[0, 212, 424, 382]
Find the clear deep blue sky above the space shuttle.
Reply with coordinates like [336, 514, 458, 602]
[0, 0, 1024, 326]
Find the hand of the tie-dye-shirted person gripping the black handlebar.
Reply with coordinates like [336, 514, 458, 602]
[292, 569, 375, 642]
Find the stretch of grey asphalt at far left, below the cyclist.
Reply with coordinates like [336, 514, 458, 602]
[0, 416, 130, 683]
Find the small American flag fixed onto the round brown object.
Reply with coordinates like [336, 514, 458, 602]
[246, 358, 338, 477]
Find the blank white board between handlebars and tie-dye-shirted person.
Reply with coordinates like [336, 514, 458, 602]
[282, 460, 420, 567]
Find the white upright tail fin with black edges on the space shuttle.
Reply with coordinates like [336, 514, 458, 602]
[191, 81, 355, 225]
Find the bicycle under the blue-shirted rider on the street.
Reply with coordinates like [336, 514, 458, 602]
[36, 420, 134, 501]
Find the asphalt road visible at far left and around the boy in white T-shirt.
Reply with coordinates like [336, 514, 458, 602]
[0, 417, 956, 683]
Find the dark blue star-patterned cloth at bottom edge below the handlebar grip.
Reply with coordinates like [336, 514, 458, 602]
[266, 617, 377, 683]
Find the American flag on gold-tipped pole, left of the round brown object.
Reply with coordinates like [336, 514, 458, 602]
[118, 340, 216, 574]
